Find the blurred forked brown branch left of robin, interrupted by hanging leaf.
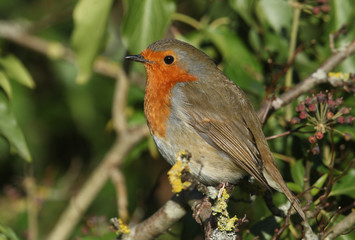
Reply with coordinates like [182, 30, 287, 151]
[0, 18, 149, 240]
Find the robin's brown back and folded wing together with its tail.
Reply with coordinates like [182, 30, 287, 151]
[177, 77, 305, 219]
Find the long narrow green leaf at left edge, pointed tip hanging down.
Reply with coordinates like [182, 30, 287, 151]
[0, 93, 31, 162]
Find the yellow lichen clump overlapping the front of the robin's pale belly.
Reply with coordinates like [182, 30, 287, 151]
[168, 151, 191, 193]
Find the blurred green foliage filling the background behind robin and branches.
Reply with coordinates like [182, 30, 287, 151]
[0, 0, 355, 239]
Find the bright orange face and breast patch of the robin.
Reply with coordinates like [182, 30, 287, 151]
[142, 49, 197, 137]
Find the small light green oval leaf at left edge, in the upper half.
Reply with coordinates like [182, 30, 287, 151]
[0, 55, 36, 88]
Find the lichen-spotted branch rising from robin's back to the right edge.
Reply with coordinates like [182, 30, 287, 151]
[258, 40, 355, 122]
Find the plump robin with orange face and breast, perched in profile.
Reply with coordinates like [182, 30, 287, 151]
[125, 39, 305, 220]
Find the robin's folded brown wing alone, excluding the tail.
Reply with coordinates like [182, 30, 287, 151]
[179, 80, 269, 187]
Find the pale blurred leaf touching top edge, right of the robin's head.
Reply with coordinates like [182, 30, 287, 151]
[257, 0, 292, 33]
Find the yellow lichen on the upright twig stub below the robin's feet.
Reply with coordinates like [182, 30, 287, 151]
[212, 189, 238, 231]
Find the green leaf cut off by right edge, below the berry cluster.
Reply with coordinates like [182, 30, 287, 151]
[329, 169, 355, 198]
